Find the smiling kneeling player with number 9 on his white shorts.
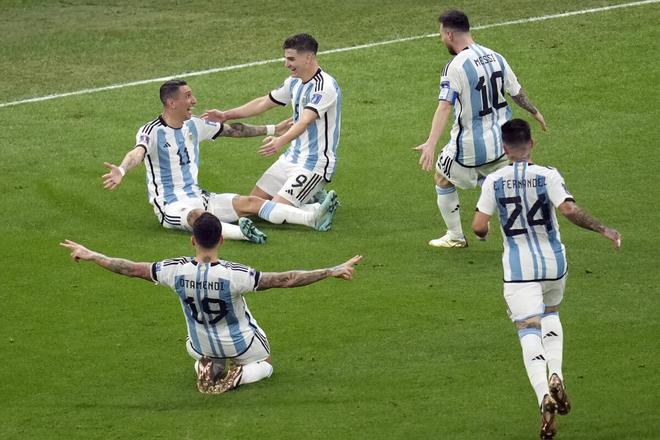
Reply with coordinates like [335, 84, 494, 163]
[202, 34, 341, 215]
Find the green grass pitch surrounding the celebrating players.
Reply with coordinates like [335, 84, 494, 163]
[0, 0, 660, 439]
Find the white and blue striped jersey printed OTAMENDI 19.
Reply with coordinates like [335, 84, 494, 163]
[151, 257, 268, 358]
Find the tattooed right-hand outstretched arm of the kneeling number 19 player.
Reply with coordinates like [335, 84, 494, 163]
[257, 255, 362, 290]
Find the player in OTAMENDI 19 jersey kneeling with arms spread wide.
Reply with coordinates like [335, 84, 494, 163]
[60, 213, 362, 394]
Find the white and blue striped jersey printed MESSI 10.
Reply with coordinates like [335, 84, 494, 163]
[439, 43, 520, 167]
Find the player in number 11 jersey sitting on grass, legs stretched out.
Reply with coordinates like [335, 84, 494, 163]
[103, 80, 334, 243]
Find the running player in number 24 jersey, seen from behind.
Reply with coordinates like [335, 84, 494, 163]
[472, 119, 621, 439]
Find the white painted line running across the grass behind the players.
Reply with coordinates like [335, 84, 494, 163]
[0, 0, 660, 108]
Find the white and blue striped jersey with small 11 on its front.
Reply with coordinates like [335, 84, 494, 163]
[135, 116, 223, 216]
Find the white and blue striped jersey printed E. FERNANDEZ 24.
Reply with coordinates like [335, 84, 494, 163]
[477, 162, 574, 282]
